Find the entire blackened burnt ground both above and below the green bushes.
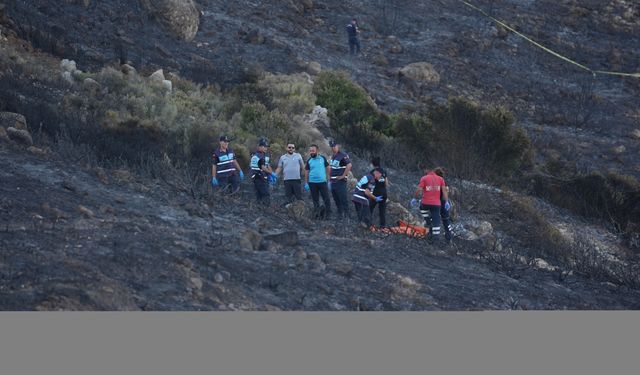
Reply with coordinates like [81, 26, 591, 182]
[0, 0, 640, 310]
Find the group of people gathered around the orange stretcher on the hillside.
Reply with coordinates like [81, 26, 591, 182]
[211, 135, 452, 244]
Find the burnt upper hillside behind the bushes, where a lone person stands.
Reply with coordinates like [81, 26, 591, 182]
[5, 0, 640, 176]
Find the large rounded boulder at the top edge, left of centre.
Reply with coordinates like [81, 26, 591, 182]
[140, 0, 200, 41]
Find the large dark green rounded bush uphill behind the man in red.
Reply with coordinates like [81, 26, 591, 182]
[394, 98, 533, 182]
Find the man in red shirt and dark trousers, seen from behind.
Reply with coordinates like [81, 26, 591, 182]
[411, 170, 451, 242]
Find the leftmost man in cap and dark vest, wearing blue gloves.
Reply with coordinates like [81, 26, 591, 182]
[211, 135, 244, 194]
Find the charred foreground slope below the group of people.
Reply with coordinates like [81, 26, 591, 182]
[0, 141, 640, 310]
